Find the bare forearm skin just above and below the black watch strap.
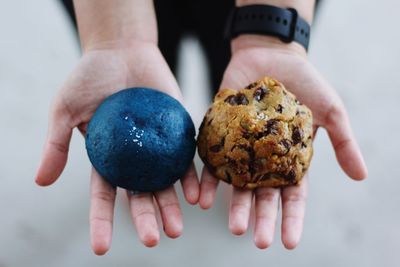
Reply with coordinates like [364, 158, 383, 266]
[232, 0, 315, 56]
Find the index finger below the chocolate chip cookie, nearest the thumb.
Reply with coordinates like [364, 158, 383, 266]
[281, 175, 308, 249]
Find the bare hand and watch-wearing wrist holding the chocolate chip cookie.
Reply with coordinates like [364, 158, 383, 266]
[199, 0, 367, 249]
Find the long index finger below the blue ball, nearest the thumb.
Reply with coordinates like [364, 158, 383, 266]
[90, 169, 116, 255]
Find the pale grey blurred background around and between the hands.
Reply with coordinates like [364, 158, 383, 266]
[0, 0, 400, 267]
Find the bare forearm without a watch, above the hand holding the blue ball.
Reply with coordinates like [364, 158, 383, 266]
[74, 0, 157, 51]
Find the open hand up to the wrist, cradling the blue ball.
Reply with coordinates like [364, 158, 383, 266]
[36, 42, 199, 255]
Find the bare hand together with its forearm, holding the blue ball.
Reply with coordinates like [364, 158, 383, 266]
[36, 0, 199, 255]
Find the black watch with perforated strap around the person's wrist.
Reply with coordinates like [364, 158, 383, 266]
[225, 5, 310, 50]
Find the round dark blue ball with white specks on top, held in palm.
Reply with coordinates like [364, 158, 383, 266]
[86, 88, 196, 192]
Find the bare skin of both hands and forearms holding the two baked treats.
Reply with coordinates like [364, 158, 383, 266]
[36, 0, 367, 255]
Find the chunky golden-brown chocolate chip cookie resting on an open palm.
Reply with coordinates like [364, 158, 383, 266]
[197, 77, 313, 189]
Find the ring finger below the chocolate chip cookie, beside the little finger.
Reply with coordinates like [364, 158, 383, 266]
[229, 188, 253, 235]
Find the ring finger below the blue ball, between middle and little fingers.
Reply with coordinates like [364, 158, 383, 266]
[155, 186, 183, 238]
